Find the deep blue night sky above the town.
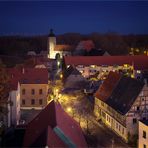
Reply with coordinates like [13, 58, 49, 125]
[0, 1, 148, 35]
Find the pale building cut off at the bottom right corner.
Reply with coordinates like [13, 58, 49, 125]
[138, 120, 148, 148]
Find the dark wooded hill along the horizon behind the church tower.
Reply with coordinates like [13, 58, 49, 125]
[0, 33, 148, 56]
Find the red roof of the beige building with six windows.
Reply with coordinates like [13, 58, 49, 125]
[7, 68, 48, 90]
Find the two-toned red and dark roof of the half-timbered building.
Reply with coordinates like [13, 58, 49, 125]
[95, 72, 144, 115]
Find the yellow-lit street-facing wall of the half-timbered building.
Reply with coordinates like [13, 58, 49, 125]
[94, 98, 128, 142]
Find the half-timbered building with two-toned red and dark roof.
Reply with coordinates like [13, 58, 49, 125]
[94, 72, 148, 142]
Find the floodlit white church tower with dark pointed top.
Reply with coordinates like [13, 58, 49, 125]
[47, 29, 56, 59]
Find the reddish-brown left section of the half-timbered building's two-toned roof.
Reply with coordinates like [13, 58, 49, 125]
[95, 72, 121, 102]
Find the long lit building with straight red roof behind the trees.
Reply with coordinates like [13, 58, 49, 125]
[64, 55, 148, 79]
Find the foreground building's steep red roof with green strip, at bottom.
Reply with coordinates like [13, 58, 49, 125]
[23, 100, 87, 147]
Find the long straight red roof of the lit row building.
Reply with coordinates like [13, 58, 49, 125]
[64, 55, 148, 70]
